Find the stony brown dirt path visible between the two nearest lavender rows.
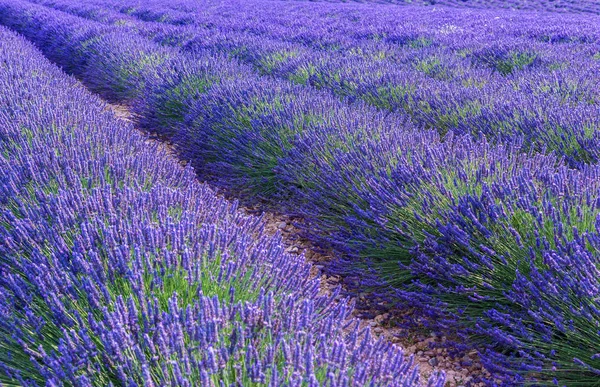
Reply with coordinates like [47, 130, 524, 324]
[107, 103, 489, 387]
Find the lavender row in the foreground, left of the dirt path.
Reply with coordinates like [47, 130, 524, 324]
[0, 28, 443, 387]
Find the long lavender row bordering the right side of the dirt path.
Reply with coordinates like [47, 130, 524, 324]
[1, 1, 600, 385]
